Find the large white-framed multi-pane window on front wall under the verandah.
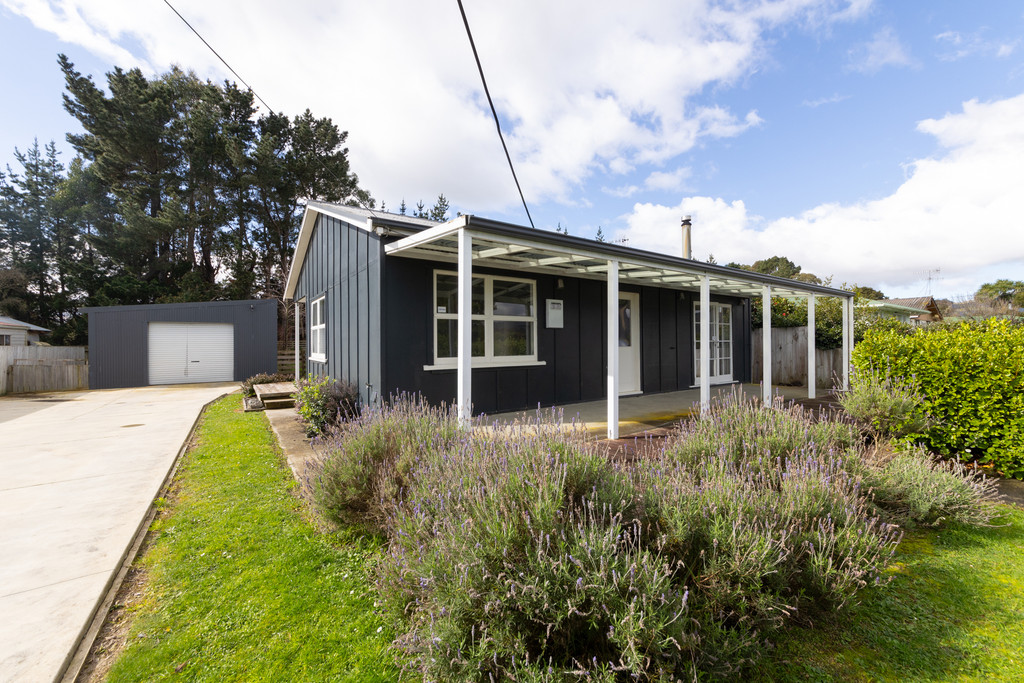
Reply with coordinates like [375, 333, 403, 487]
[434, 270, 537, 367]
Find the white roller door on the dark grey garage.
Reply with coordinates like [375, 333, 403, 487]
[150, 323, 234, 384]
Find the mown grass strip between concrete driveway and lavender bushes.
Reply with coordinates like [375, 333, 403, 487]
[109, 395, 398, 682]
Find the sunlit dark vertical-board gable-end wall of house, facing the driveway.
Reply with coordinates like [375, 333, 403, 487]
[295, 214, 383, 404]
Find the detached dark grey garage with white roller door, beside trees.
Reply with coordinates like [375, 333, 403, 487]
[81, 299, 278, 389]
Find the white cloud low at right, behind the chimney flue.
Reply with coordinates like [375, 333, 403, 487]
[614, 94, 1024, 294]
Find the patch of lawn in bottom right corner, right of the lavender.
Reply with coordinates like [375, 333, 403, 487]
[758, 507, 1024, 682]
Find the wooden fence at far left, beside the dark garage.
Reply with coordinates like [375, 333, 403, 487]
[0, 346, 89, 395]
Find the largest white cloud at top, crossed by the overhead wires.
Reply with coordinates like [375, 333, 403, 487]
[0, 0, 870, 213]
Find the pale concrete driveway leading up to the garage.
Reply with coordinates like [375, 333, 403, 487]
[0, 383, 238, 682]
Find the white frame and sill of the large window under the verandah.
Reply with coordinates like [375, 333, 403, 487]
[424, 270, 547, 370]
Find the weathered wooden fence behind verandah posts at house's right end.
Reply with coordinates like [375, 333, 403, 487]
[751, 328, 843, 391]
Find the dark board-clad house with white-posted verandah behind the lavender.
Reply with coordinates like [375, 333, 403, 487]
[285, 203, 853, 436]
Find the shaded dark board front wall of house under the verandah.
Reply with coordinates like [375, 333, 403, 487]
[380, 257, 750, 414]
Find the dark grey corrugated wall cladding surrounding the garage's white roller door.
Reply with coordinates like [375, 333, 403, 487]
[82, 299, 278, 389]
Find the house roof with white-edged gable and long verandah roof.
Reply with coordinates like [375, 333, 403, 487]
[285, 202, 853, 298]
